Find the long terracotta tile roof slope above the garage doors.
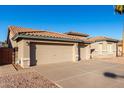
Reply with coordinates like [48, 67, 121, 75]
[9, 26, 86, 41]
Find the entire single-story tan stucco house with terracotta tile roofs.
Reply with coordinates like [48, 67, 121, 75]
[7, 26, 118, 68]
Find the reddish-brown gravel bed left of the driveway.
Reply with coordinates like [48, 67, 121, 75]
[0, 71, 58, 88]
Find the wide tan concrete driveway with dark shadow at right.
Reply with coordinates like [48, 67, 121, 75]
[32, 60, 124, 88]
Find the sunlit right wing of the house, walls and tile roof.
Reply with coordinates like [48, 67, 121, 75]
[88, 36, 118, 58]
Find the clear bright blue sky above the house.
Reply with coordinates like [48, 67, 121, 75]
[0, 5, 124, 41]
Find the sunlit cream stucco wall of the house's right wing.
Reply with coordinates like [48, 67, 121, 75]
[91, 41, 117, 58]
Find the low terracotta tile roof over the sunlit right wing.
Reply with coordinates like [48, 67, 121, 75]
[87, 36, 118, 42]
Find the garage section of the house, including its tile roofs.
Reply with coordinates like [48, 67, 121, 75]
[7, 26, 90, 68]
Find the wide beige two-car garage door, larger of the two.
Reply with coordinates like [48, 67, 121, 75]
[30, 44, 73, 65]
